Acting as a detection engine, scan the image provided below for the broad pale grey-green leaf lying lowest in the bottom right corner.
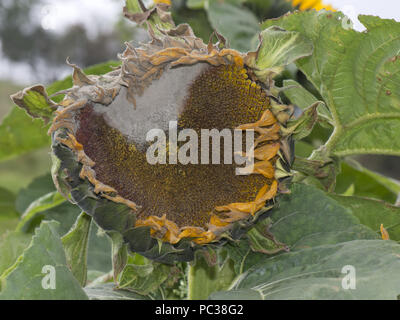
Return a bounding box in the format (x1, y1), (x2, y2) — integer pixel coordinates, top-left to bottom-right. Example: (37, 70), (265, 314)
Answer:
(211, 240), (400, 300)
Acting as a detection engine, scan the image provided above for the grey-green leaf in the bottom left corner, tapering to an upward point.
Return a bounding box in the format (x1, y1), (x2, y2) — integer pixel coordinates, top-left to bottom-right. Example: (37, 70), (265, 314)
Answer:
(0, 222), (87, 300)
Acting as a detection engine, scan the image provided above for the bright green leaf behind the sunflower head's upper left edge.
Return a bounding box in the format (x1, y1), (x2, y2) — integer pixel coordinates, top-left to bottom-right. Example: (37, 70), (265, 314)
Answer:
(0, 61), (119, 161)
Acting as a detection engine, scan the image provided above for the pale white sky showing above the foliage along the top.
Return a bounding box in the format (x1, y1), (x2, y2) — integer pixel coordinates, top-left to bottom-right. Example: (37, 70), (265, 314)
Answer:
(0, 0), (400, 83)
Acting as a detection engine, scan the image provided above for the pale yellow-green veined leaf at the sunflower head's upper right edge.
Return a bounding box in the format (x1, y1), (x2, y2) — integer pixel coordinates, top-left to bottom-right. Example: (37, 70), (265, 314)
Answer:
(249, 27), (313, 81)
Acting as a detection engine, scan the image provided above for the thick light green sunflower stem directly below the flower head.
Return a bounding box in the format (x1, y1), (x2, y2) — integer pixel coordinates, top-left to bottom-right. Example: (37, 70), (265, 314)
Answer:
(188, 252), (236, 300)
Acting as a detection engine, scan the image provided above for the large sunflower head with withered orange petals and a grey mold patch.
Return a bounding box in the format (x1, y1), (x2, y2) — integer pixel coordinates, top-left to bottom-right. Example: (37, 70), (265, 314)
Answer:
(38, 3), (291, 262)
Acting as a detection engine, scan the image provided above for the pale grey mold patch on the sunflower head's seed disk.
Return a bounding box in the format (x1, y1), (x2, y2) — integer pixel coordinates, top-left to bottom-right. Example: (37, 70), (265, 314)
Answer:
(94, 63), (209, 148)
